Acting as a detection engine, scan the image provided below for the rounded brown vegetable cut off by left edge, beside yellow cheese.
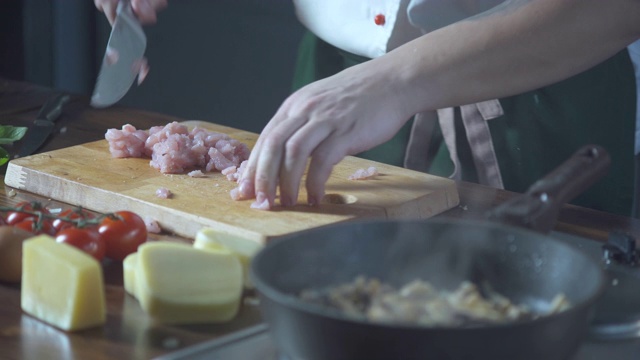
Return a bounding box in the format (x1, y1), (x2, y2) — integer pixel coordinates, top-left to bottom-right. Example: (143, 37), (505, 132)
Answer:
(0, 226), (34, 283)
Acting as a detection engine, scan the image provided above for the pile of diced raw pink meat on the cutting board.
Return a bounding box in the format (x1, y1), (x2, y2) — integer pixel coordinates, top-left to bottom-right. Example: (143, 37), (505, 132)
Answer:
(105, 122), (250, 174)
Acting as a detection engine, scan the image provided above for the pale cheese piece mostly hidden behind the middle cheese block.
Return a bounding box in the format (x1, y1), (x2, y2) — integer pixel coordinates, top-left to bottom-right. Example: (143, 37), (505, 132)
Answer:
(193, 228), (264, 288)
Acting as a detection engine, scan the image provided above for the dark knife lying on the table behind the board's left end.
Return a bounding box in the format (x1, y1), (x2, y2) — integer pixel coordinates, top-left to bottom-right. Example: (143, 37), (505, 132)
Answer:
(18, 94), (70, 157)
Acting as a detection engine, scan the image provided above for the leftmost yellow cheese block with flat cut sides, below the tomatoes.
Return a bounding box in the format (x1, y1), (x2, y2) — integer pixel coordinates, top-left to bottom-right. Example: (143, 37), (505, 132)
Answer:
(20, 235), (106, 331)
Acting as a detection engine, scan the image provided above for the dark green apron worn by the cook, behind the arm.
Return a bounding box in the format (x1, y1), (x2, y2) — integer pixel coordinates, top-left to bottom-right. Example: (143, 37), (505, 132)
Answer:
(293, 33), (636, 216)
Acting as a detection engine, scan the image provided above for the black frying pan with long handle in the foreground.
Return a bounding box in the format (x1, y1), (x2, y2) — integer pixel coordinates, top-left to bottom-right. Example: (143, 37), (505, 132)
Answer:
(251, 146), (609, 360)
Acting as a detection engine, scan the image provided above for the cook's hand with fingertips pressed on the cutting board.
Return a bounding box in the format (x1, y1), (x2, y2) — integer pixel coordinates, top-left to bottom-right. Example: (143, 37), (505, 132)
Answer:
(238, 59), (413, 207)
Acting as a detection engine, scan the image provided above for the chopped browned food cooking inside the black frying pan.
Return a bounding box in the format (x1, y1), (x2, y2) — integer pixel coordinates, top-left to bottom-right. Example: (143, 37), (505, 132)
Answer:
(300, 276), (570, 327)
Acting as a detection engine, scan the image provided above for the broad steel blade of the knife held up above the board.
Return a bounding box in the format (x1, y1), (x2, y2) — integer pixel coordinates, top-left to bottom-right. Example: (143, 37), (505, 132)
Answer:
(91, 0), (147, 108)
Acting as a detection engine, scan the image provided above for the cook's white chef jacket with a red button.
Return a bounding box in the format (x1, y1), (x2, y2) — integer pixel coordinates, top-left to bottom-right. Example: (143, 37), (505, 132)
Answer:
(293, 0), (640, 154)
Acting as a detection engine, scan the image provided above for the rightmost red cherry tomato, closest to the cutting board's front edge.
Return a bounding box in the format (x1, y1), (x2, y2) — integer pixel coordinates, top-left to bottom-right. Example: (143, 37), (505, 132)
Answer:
(98, 211), (147, 261)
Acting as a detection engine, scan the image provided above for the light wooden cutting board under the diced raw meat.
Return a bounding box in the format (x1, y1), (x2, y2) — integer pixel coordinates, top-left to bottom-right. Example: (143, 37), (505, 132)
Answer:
(5, 121), (459, 242)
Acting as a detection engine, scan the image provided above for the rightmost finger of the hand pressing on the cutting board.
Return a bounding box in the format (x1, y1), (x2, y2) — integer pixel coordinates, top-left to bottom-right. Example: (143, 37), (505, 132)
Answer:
(306, 137), (347, 206)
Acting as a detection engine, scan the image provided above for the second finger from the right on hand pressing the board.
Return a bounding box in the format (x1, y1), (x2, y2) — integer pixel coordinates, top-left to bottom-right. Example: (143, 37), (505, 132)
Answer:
(279, 122), (331, 206)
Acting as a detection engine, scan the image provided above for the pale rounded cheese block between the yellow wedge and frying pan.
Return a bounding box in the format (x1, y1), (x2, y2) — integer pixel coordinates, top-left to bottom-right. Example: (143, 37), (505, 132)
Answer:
(134, 241), (242, 324)
